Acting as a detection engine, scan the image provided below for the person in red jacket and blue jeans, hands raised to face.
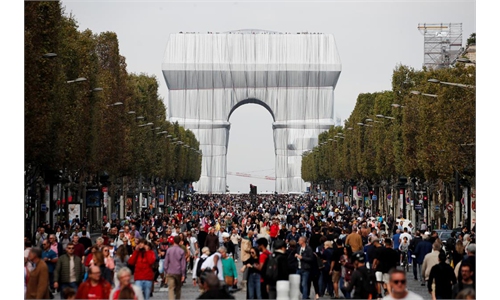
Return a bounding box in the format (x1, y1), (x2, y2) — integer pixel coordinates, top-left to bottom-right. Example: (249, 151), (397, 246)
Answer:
(128, 239), (156, 300)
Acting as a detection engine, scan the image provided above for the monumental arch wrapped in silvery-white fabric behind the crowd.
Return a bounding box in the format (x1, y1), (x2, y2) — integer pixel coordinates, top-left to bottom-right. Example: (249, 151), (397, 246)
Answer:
(162, 30), (342, 193)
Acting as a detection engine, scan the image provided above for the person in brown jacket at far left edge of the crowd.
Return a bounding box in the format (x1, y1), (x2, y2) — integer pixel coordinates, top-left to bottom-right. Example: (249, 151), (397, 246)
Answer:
(26, 247), (50, 299)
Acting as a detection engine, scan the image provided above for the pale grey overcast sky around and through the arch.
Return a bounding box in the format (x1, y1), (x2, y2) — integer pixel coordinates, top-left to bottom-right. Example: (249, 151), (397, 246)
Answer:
(56, 0), (476, 192)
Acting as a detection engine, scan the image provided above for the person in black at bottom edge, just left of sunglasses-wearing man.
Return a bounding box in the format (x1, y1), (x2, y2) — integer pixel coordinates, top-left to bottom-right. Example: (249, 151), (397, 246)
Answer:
(341, 251), (377, 299)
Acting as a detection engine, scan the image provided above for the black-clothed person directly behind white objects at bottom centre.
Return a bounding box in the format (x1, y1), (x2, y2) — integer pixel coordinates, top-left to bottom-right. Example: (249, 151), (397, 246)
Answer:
(266, 240), (288, 299)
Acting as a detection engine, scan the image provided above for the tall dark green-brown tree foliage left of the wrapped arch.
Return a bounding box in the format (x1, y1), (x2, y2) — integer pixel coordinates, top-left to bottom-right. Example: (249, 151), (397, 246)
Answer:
(25, 1), (201, 190)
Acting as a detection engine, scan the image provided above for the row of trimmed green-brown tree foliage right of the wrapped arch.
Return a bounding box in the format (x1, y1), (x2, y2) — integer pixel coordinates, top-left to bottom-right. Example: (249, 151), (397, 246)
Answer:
(302, 64), (476, 192)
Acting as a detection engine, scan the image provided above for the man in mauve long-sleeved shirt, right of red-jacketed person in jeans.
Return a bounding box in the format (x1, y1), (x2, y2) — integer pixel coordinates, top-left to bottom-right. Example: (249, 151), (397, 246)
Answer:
(163, 235), (186, 300)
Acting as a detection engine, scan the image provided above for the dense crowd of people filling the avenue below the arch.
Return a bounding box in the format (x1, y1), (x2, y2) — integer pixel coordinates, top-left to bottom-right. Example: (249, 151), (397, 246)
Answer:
(25, 195), (476, 299)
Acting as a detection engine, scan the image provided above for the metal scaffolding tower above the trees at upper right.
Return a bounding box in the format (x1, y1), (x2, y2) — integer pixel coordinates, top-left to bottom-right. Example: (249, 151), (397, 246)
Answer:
(418, 23), (464, 69)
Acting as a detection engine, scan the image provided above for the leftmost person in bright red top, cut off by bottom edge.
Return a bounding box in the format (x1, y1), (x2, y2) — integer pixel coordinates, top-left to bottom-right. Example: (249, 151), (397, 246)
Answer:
(75, 266), (111, 299)
